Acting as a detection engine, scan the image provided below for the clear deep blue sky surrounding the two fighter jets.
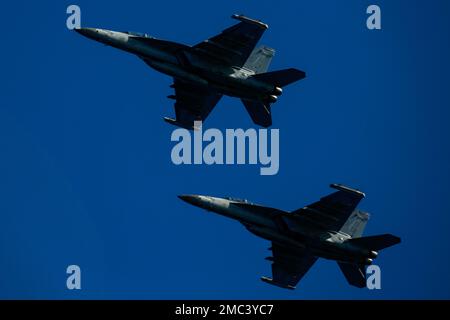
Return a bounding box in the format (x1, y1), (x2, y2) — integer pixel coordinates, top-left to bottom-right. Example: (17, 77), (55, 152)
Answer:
(0, 0), (450, 299)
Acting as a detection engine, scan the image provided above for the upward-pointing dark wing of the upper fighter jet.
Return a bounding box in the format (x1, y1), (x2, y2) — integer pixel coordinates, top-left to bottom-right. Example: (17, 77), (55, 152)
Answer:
(193, 15), (268, 67)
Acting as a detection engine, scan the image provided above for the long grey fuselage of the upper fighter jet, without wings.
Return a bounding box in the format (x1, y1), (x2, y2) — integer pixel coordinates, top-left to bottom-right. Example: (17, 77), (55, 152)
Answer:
(77, 28), (282, 103)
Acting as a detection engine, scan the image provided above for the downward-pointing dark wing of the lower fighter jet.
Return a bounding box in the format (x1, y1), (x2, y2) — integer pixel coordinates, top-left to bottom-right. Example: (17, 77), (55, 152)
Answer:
(261, 242), (317, 289)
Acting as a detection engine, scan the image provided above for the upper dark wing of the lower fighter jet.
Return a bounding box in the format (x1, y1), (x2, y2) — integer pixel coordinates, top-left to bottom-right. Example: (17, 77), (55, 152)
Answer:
(292, 184), (365, 231)
